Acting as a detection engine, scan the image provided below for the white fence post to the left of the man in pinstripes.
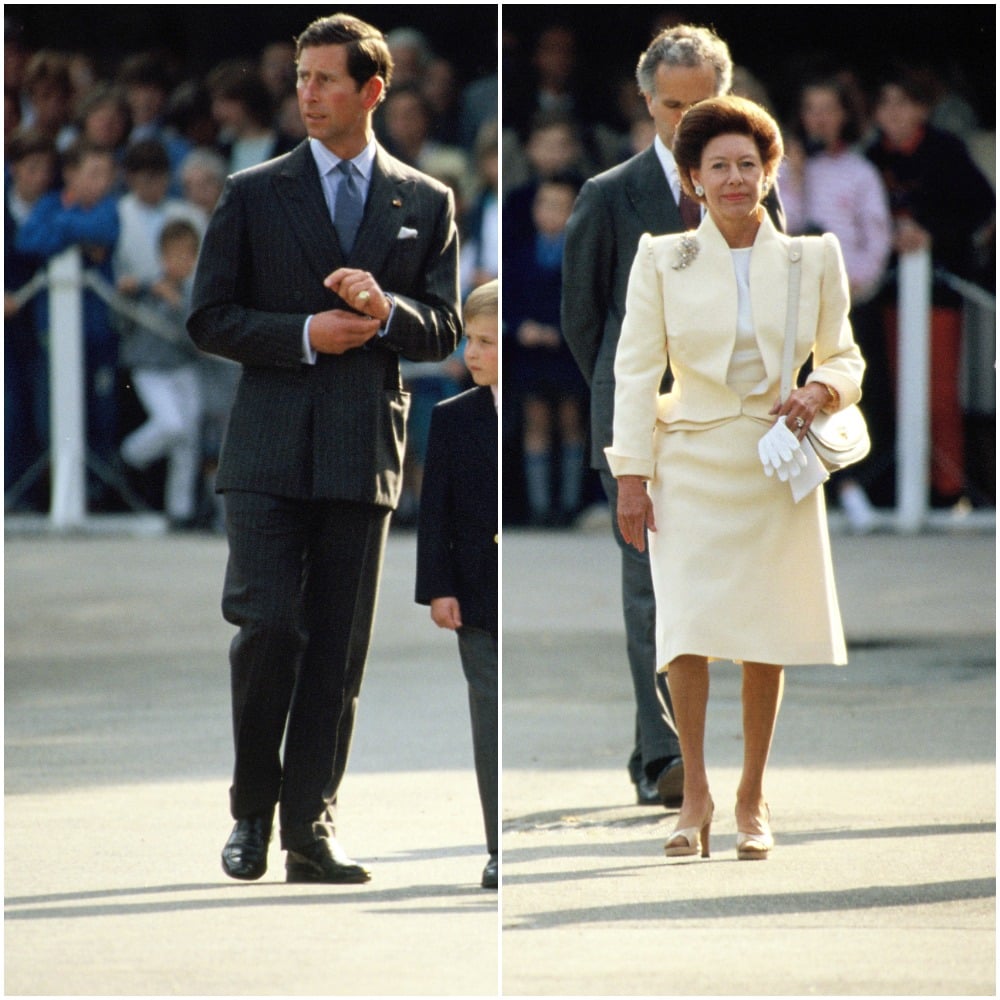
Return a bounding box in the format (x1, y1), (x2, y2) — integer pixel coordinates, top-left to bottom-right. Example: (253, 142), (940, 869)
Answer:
(48, 247), (87, 529)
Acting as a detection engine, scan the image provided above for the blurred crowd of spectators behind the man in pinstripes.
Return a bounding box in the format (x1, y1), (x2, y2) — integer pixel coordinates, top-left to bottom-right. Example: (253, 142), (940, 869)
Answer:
(4, 19), (499, 529)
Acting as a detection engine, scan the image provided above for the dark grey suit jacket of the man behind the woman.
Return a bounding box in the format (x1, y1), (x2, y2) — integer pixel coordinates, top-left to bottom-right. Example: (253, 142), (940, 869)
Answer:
(561, 146), (784, 471)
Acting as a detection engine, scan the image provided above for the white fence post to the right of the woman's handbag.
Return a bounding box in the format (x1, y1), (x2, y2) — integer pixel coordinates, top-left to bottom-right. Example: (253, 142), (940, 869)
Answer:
(896, 250), (931, 532)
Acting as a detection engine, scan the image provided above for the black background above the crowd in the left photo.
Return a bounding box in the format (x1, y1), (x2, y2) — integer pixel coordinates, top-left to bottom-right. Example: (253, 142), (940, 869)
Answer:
(4, 4), (497, 82)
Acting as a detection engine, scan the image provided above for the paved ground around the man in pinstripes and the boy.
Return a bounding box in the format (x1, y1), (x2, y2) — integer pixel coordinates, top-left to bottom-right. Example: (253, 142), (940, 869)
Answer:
(4, 536), (499, 995)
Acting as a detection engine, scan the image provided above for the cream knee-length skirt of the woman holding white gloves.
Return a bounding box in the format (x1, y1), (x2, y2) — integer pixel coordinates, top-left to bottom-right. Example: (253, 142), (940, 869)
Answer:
(649, 417), (847, 672)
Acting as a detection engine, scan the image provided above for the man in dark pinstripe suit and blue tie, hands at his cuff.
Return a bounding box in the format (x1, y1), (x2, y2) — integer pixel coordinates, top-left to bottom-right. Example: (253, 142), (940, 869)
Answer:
(188, 14), (461, 882)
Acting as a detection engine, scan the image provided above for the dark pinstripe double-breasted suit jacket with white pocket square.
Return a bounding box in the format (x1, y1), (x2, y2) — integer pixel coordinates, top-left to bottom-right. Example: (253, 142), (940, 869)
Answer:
(188, 142), (461, 507)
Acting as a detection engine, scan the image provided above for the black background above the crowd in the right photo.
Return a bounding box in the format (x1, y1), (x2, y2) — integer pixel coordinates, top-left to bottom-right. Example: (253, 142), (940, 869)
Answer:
(503, 4), (996, 129)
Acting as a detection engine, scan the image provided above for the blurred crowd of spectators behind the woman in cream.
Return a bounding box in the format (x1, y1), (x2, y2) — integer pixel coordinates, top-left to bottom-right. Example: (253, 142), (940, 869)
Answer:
(501, 17), (995, 530)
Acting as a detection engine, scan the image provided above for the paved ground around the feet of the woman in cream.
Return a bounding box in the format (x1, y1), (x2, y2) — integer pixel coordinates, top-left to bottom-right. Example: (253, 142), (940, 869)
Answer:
(503, 531), (996, 996)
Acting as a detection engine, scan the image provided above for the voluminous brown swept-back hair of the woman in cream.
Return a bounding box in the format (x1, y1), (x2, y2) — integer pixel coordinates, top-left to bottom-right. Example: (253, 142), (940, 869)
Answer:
(674, 95), (785, 197)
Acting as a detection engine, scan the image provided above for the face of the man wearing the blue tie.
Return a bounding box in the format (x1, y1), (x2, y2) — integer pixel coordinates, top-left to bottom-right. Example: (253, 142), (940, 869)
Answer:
(297, 45), (383, 156)
